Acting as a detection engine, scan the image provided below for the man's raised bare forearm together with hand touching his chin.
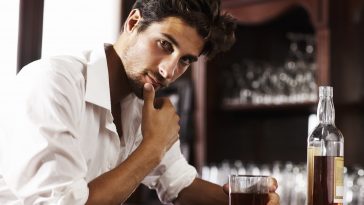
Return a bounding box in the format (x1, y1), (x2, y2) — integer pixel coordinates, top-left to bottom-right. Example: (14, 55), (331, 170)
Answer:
(86, 84), (179, 205)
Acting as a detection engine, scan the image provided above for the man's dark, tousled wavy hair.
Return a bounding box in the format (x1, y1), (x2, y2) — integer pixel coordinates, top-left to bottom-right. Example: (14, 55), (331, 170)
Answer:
(133, 0), (236, 58)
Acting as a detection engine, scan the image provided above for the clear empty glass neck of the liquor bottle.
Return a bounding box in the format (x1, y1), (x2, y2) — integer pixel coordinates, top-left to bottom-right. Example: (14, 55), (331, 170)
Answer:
(317, 97), (335, 125)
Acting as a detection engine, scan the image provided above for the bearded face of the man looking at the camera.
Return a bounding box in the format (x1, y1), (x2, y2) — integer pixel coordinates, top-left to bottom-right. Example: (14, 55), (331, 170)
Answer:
(122, 17), (204, 98)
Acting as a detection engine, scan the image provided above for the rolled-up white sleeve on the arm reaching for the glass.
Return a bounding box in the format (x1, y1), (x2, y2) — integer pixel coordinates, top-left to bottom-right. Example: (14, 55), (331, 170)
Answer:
(143, 141), (197, 204)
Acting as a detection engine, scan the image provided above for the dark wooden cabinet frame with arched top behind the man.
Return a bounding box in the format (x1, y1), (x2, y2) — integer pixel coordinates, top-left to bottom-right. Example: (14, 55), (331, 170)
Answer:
(193, 0), (330, 171)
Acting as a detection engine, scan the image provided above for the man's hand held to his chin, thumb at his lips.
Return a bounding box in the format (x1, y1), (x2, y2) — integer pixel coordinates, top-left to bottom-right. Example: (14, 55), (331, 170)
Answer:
(142, 83), (180, 157)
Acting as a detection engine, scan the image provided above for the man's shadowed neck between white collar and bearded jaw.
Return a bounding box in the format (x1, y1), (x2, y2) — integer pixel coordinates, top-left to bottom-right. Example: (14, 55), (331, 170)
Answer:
(105, 45), (131, 105)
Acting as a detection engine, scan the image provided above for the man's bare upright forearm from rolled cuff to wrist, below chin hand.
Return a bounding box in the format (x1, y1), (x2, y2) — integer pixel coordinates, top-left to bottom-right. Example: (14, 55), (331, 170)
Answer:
(86, 143), (161, 205)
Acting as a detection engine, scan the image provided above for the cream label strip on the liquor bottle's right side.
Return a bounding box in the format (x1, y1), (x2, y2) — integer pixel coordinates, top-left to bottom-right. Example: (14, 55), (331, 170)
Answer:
(334, 157), (344, 203)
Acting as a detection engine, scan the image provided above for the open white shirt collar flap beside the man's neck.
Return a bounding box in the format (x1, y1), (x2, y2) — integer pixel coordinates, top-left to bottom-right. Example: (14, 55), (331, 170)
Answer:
(85, 46), (111, 110)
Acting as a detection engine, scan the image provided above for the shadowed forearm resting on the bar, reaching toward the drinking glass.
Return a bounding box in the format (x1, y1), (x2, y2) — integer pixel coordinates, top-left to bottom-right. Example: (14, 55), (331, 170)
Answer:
(176, 178), (229, 205)
